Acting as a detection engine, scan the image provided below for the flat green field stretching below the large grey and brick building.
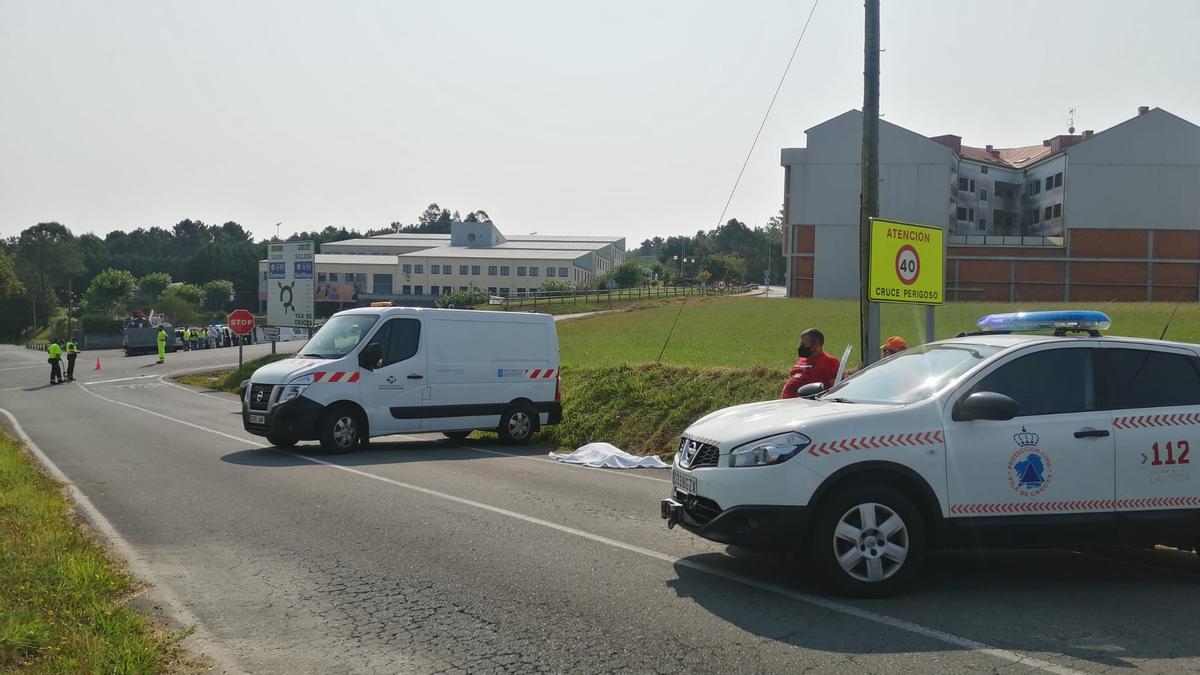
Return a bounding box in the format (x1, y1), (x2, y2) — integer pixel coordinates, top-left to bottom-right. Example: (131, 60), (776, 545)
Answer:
(558, 298), (1200, 368)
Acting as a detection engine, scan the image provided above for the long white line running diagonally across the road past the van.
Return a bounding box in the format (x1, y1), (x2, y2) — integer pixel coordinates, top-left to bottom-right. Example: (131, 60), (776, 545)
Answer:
(72, 389), (1084, 675)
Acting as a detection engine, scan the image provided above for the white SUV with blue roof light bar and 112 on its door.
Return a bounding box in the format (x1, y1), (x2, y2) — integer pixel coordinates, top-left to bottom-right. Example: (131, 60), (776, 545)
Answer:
(661, 311), (1200, 596)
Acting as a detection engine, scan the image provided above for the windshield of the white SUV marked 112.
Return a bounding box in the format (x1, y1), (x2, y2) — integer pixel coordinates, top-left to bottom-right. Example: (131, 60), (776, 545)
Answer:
(821, 345), (1000, 404)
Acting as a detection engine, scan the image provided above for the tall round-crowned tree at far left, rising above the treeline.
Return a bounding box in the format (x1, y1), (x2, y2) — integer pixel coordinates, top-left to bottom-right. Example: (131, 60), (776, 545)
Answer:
(17, 222), (84, 321)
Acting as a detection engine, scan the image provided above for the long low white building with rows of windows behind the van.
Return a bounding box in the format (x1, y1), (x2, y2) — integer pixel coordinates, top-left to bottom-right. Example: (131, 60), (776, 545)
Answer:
(258, 222), (625, 306)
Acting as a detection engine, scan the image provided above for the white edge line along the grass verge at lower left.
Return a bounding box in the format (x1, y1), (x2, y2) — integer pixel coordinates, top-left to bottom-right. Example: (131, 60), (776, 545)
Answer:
(0, 408), (245, 673)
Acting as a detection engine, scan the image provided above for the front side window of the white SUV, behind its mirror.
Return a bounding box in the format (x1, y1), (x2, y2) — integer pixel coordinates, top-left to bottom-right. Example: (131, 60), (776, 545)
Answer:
(972, 347), (1096, 417)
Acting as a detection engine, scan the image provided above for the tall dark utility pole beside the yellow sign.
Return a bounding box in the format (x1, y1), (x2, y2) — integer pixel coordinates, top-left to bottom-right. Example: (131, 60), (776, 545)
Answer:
(858, 0), (880, 364)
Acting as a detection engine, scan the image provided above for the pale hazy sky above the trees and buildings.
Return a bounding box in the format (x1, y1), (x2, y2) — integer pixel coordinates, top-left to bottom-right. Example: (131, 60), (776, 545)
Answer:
(0, 0), (1200, 247)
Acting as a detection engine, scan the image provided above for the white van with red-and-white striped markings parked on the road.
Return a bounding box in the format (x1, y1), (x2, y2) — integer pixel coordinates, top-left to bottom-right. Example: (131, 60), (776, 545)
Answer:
(241, 307), (563, 453)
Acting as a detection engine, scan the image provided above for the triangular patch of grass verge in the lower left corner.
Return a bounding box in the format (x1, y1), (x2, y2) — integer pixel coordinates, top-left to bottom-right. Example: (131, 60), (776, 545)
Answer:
(0, 432), (181, 673)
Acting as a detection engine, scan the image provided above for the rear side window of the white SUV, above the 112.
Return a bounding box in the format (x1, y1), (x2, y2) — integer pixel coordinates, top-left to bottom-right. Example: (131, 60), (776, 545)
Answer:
(1100, 350), (1200, 410)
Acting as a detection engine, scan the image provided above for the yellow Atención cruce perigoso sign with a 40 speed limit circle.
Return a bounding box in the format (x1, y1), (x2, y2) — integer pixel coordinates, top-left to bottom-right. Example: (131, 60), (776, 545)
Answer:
(868, 219), (946, 305)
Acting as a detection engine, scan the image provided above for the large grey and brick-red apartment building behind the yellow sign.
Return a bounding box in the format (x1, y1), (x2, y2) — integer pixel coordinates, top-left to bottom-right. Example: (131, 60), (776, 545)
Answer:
(782, 108), (1200, 301)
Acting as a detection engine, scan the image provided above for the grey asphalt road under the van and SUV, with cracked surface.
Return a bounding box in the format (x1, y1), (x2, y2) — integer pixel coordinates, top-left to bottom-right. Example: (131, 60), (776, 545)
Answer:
(0, 345), (1200, 673)
